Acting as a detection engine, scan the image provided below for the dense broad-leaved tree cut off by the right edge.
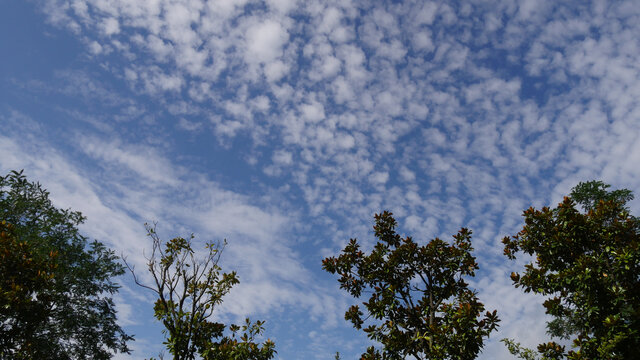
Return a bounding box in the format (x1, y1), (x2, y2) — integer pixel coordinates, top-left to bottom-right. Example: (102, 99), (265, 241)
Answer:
(503, 181), (640, 359)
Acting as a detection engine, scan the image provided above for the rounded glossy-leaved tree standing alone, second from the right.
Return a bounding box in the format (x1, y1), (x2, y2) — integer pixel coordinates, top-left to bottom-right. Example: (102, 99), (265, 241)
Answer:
(322, 211), (499, 359)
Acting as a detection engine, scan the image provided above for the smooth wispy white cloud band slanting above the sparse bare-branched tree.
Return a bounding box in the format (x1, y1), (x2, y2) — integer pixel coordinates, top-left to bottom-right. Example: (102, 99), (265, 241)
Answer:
(0, 108), (350, 356)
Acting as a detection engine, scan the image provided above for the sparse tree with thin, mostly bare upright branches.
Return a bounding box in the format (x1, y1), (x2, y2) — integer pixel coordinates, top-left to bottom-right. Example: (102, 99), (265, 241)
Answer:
(125, 224), (275, 360)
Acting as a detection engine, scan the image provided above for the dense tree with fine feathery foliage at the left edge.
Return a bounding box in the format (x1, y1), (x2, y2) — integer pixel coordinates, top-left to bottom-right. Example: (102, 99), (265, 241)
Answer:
(0, 171), (132, 359)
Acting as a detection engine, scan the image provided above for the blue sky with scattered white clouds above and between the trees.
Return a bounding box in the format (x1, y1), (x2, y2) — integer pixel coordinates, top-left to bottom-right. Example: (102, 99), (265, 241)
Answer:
(0, 0), (640, 359)
